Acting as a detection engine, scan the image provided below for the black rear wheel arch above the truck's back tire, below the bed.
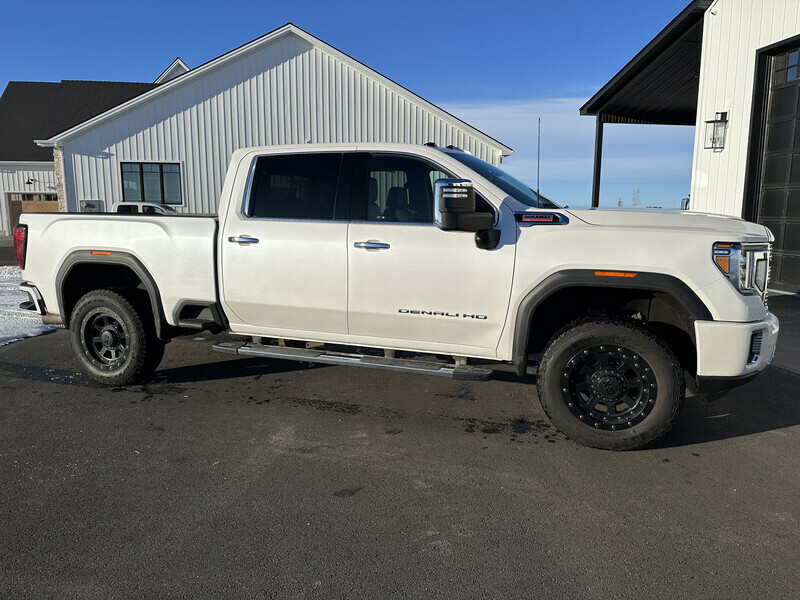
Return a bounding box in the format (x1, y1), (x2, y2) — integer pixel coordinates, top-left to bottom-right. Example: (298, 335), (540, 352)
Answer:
(56, 250), (169, 339)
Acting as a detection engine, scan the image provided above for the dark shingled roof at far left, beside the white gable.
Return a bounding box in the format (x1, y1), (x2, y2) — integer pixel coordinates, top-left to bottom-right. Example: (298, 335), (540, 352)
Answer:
(0, 80), (155, 162)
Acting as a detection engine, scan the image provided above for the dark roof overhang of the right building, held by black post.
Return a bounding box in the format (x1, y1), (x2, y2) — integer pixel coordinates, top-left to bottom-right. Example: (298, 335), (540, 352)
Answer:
(581, 0), (713, 125)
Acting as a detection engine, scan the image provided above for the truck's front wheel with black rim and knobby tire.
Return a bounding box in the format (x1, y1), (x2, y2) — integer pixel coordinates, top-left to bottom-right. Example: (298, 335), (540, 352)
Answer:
(537, 317), (685, 450)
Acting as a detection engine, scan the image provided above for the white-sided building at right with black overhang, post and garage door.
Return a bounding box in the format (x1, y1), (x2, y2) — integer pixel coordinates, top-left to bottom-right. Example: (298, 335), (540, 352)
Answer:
(581, 0), (800, 291)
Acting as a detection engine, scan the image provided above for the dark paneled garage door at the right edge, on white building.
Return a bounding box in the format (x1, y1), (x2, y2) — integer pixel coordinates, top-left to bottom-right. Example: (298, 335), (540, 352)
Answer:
(758, 49), (800, 291)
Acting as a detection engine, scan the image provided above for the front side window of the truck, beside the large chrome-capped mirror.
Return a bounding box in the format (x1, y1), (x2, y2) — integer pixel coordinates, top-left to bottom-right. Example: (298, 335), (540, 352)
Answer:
(367, 154), (452, 223)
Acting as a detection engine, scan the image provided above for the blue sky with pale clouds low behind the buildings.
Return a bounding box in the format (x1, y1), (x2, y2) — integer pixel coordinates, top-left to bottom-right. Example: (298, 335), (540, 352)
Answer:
(0, 0), (694, 207)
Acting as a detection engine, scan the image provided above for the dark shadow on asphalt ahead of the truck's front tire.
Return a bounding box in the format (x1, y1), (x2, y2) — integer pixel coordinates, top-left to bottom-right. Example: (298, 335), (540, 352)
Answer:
(649, 365), (800, 449)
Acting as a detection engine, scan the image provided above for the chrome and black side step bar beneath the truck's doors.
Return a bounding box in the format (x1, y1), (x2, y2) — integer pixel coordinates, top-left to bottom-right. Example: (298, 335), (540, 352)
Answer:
(213, 342), (492, 381)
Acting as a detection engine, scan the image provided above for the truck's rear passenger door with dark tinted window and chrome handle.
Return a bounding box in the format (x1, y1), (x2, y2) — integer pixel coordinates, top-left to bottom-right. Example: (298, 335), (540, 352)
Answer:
(220, 152), (349, 338)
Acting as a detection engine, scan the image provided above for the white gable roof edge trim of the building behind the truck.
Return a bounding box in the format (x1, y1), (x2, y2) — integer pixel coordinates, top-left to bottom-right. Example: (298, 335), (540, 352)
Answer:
(37, 23), (514, 156)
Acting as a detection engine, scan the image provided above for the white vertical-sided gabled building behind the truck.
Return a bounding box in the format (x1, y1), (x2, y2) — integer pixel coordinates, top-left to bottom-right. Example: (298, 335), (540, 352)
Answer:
(39, 24), (513, 212)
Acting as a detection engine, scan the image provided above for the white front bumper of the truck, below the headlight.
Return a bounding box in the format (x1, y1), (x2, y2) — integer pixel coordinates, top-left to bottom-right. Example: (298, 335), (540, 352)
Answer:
(694, 313), (780, 396)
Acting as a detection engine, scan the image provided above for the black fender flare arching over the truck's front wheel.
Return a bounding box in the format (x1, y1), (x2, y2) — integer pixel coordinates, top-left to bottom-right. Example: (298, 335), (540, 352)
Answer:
(512, 269), (713, 377)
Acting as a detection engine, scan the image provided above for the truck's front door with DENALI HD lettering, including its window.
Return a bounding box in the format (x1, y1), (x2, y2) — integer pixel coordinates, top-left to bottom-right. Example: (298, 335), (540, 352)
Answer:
(347, 153), (514, 356)
